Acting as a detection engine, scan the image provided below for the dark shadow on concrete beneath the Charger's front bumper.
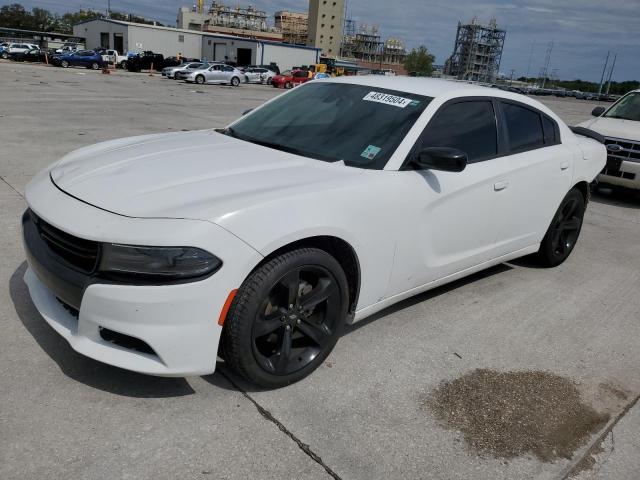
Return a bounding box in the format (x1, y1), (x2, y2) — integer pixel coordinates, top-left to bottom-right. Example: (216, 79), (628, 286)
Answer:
(9, 262), (195, 398)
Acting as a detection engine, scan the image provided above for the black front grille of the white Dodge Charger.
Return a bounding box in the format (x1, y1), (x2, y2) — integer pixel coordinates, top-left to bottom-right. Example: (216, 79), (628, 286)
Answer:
(29, 211), (100, 273)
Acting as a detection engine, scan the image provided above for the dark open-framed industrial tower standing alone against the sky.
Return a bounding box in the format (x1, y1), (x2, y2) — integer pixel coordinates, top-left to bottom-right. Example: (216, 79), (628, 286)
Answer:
(444, 18), (507, 83)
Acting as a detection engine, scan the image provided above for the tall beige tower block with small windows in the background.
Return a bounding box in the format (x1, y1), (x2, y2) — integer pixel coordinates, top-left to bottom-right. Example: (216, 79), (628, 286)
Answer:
(307, 0), (344, 57)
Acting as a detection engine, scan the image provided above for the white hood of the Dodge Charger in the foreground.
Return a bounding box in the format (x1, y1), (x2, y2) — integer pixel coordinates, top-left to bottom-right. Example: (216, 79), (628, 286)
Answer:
(50, 130), (362, 223)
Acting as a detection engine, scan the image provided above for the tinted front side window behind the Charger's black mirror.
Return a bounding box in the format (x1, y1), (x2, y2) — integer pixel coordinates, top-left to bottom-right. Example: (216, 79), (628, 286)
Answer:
(418, 100), (498, 163)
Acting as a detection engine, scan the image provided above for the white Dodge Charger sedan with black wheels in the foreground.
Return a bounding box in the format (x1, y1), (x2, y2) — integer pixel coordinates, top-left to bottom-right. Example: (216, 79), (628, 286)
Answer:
(22, 76), (606, 388)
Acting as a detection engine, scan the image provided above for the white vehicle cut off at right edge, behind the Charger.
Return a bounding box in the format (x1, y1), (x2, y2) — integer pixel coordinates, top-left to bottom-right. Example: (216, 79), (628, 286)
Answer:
(580, 90), (640, 190)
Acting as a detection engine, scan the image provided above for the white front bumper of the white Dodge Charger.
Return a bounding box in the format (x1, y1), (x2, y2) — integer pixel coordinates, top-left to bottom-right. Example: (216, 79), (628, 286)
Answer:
(24, 172), (262, 376)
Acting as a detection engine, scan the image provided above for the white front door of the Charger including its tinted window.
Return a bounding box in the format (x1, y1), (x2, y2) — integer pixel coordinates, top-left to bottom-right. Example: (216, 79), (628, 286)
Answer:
(389, 98), (504, 295)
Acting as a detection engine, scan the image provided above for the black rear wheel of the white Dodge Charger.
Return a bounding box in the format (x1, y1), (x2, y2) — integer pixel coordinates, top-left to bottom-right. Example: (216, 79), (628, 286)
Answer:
(536, 188), (586, 268)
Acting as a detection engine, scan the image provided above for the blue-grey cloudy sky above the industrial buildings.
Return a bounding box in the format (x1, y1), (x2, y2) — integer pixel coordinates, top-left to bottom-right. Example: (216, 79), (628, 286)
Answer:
(10, 0), (640, 82)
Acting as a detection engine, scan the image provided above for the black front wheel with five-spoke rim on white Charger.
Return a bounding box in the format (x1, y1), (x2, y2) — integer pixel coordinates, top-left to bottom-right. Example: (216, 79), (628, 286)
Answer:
(222, 248), (349, 388)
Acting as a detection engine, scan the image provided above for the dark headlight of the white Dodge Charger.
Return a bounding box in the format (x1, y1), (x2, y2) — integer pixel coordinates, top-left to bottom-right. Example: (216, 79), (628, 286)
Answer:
(99, 243), (222, 281)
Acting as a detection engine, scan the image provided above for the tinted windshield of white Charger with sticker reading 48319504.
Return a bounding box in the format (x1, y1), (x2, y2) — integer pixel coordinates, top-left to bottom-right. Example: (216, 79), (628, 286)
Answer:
(224, 82), (432, 170)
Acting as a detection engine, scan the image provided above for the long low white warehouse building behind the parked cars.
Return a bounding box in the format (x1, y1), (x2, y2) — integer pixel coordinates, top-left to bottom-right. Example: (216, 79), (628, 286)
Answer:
(73, 18), (320, 70)
